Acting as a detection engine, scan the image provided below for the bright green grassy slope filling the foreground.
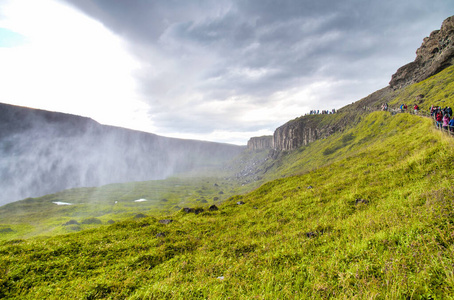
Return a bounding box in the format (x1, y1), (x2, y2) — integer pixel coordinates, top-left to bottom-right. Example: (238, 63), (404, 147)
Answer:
(0, 112), (454, 299)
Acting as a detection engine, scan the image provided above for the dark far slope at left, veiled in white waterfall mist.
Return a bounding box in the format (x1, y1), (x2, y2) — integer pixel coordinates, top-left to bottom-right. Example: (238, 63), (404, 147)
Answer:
(0, 104), (244, 204)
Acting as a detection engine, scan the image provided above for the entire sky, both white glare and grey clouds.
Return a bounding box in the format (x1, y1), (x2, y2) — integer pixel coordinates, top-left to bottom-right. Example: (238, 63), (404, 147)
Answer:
(0, 0), (454, 145)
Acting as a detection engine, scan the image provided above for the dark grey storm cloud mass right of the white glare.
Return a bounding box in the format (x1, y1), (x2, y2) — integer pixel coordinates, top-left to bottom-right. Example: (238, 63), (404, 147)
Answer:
(61, 0), (454, 142)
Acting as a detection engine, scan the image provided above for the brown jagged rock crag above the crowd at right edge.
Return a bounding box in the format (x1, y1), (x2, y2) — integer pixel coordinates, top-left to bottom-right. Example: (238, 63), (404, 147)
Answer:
(389, 16), (454, 89)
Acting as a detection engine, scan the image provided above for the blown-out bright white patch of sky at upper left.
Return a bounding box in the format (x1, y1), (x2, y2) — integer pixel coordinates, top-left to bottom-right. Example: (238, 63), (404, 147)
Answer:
(0, 0), (153, 132)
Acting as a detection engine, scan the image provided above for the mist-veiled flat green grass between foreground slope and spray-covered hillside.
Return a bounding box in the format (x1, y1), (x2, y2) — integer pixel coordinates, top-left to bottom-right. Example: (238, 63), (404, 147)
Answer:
(0, 176), (255, 240)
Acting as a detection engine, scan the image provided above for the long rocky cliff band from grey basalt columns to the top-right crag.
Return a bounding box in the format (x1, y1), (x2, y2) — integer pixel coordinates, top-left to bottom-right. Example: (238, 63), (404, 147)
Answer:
(248, 16), (454, 153)
